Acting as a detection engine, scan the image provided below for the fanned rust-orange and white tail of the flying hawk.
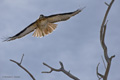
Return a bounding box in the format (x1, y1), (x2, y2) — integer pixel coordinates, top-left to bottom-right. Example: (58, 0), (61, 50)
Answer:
(33, 23), (57, 37)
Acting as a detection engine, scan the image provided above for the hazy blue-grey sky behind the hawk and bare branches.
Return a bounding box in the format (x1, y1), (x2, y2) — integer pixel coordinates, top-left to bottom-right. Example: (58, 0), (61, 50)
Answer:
(0, 0), (120, 80)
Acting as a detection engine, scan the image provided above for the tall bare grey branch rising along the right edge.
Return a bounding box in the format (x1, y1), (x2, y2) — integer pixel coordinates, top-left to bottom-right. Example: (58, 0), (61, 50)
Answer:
(96, 0), (115, 80)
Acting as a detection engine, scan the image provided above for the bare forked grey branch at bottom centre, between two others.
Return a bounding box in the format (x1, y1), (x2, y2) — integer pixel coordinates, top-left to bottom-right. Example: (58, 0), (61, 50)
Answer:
(42, 62), (80, 80)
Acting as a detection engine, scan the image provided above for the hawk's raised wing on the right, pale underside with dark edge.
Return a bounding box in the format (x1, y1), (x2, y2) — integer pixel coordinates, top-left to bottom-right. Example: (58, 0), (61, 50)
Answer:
(46, 9), (83, 23)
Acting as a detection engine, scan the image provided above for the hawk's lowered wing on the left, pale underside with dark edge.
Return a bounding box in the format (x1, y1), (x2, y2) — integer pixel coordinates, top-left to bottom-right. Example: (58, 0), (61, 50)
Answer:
(4, 22), (37, 41)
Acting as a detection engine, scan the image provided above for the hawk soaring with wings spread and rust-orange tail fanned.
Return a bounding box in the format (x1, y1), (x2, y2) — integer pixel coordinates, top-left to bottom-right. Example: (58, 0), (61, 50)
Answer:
(4, 8), (83, 41)
